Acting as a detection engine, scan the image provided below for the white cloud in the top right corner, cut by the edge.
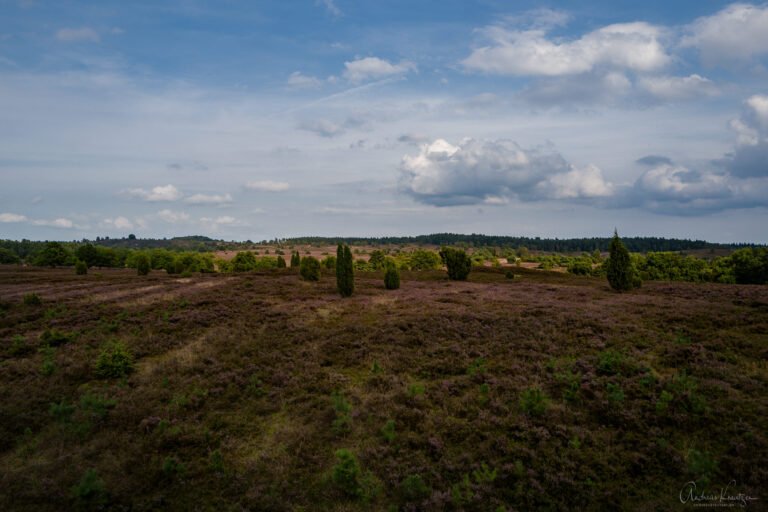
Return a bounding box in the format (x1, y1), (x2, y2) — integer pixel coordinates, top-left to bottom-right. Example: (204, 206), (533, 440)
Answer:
(681, 4), (768, 65)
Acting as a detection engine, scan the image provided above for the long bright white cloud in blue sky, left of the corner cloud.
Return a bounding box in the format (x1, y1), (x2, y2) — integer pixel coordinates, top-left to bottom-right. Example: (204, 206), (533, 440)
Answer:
(462, 22), (671, 76)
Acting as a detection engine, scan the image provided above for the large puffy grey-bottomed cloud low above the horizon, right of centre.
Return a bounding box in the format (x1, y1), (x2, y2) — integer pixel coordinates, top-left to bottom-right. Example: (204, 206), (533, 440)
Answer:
(400, 139), (613, 206)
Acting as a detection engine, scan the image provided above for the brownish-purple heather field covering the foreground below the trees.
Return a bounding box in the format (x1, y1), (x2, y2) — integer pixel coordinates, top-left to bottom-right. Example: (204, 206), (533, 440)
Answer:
(0, 266), (768, 510)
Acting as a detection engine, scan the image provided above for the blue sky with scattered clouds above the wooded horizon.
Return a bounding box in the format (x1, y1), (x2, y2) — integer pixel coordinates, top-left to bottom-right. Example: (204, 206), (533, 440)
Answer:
(0, 0), (768, 243)
